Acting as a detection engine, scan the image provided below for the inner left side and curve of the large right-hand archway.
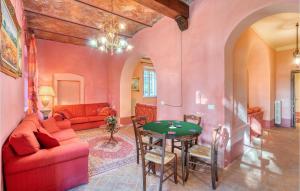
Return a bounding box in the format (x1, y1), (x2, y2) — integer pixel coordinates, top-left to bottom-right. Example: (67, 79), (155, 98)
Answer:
(224, 2), (299, 166)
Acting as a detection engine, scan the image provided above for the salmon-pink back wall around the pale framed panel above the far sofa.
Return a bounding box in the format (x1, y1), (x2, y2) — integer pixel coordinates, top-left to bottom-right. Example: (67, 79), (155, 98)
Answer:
(37, 40), (108, 103)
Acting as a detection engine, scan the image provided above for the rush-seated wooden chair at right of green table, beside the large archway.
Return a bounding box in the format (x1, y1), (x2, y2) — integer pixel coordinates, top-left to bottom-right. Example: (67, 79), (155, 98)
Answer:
(185, 125), (222, 190)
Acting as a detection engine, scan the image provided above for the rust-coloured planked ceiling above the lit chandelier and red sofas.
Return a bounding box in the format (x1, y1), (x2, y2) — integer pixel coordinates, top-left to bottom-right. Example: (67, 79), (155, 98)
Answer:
(24, 0), (162, 45)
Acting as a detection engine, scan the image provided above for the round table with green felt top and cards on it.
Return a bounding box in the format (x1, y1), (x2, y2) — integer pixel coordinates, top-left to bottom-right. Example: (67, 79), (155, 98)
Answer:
(143, 120), (203, 183)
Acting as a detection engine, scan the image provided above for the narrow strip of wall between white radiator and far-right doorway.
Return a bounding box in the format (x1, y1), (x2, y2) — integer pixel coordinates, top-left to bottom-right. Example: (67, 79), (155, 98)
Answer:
(276, 50), (299, 127)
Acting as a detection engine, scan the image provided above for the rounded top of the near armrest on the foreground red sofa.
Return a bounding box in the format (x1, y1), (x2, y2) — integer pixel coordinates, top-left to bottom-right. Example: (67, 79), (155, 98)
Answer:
(4, 140), (89, 175)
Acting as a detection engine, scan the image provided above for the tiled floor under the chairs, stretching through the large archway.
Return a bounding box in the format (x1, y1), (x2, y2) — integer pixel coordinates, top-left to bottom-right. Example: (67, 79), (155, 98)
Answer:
(72, 127), (300, 191)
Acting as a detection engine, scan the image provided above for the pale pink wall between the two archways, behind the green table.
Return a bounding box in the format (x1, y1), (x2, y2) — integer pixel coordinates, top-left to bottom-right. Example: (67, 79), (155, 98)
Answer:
(109, 0), (298, 166)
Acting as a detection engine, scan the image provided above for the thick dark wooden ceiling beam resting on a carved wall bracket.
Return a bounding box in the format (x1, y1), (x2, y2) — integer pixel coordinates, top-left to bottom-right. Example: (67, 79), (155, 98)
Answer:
(134, 0), (189, 31)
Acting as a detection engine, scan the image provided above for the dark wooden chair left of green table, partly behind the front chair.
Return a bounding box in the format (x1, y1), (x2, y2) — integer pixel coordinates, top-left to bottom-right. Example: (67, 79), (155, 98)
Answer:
(131, 116), (147, 164)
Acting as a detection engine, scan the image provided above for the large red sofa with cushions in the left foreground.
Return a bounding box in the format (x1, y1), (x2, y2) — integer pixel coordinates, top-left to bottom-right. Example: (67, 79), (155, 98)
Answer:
(2, 115), (89, 191)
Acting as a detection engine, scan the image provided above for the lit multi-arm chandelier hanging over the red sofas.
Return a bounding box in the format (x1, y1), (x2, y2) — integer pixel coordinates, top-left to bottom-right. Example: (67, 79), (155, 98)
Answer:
(89, 1), (133, 55)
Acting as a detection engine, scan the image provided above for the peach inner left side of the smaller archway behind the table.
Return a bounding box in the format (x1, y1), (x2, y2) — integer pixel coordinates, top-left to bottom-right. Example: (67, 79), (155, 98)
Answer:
(120, 53), (157, 124)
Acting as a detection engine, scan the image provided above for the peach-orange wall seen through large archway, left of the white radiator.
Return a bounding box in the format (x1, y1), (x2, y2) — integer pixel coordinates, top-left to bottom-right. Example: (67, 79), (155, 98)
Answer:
(234, 29), (275, 121)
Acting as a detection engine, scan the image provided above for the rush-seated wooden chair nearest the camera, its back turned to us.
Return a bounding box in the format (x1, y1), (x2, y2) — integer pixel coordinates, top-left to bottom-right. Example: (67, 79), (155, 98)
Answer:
(136, 129), (177, 191)
